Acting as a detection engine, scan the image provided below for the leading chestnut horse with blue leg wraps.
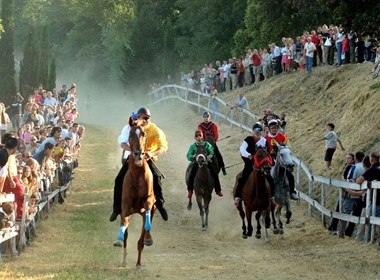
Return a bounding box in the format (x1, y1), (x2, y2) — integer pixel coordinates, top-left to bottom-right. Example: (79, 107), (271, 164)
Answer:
(114, 126), (156, 267)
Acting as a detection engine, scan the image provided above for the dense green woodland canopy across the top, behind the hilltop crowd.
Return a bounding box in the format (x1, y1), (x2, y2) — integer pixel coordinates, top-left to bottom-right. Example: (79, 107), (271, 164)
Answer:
(0, 0), (380, 98)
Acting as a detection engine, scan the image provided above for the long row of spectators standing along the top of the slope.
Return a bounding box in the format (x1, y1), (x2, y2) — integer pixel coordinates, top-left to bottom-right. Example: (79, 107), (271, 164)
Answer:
(176, 25), (380, 94)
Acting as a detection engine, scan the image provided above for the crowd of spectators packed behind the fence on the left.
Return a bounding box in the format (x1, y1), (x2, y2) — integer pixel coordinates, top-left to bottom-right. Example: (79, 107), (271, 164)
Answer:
(0, 83), (85, 249)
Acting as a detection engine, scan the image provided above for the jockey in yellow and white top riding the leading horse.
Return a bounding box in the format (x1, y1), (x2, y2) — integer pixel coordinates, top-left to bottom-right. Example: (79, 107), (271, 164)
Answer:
(110, 108), (168, 222)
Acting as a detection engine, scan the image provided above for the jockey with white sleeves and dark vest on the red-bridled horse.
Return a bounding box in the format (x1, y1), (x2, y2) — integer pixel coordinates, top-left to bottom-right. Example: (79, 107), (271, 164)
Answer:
(234, 123), (277, 207)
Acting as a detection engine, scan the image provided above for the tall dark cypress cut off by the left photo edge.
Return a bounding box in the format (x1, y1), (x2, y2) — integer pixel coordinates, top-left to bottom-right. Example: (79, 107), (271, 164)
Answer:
(0, 0), (17, 104)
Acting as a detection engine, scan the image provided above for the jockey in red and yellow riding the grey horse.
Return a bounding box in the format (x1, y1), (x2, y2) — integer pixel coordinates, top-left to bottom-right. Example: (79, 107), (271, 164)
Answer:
(265, 120), (298, 200)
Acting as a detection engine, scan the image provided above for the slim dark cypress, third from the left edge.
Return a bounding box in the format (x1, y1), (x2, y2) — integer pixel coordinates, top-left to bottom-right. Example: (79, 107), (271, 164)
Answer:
(37, 25), (49, 88)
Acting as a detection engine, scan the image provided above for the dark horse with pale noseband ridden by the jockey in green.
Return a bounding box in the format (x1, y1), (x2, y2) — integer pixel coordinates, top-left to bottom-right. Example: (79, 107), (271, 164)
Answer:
(186, 145), (214, 231)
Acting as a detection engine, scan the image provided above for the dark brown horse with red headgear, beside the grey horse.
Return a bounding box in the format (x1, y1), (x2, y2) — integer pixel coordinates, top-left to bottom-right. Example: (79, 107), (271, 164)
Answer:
(234, 148), (272, 241)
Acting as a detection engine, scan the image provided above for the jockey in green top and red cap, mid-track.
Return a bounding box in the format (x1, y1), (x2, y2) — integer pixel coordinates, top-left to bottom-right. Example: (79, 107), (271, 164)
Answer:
(186, 129), (223, 199)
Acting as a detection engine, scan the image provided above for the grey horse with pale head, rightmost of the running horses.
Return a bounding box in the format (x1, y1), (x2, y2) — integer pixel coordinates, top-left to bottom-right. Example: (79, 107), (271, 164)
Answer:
(271, 143), (294, 234)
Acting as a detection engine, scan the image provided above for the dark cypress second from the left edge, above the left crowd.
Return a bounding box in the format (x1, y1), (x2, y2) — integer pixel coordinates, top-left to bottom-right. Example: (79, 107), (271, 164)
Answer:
(19, 28), (38, 94)
